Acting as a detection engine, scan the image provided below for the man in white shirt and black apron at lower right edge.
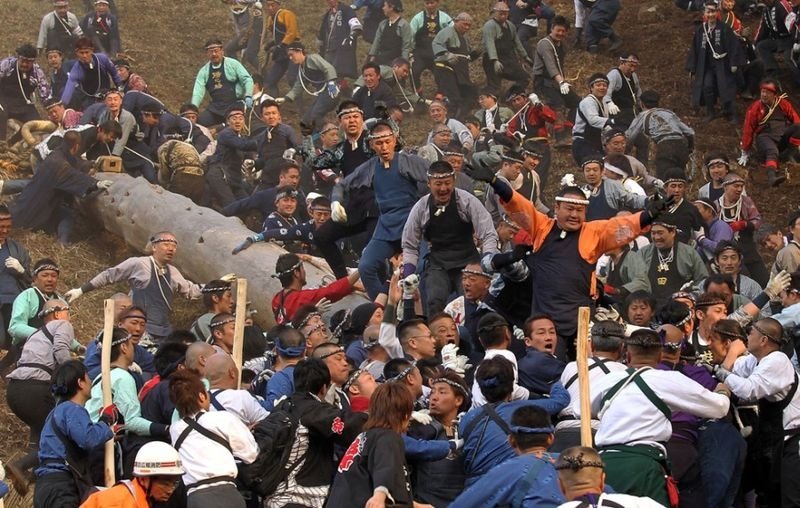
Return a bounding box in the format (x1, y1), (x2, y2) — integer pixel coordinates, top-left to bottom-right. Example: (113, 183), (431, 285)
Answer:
(715, 318), (800, 507)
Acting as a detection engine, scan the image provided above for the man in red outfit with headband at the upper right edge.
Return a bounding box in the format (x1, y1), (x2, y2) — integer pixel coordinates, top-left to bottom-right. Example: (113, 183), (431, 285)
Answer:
(738, 79), (800, 187)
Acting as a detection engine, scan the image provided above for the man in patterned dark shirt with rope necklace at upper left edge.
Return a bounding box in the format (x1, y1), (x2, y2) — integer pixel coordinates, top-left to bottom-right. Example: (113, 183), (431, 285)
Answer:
(0, 44), (51, 151)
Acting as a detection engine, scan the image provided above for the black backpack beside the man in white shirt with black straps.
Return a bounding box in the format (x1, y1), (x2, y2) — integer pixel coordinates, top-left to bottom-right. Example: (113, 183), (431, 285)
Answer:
(238, 400), (303, 497)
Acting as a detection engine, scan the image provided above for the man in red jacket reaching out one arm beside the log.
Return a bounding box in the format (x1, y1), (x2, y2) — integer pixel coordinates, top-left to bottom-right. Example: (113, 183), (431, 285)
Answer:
(272, 254), (359, 324)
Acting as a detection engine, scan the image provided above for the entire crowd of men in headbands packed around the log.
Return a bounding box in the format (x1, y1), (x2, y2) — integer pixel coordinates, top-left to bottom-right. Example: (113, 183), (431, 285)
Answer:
(0, 0), (800, 508)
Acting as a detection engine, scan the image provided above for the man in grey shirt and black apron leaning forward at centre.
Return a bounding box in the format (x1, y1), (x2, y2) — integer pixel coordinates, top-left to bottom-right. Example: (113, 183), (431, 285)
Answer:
(403, 161), (498, 316)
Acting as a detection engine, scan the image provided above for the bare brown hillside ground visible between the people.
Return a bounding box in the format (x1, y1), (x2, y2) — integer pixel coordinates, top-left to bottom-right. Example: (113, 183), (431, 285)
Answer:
(0, 0), (800, 507)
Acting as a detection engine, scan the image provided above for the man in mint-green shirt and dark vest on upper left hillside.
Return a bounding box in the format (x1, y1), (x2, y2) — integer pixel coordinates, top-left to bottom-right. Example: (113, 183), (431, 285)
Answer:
(191, 39), (253, 127)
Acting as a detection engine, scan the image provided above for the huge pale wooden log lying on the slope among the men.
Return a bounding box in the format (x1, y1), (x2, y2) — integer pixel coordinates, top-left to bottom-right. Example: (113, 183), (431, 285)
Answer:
(86, 173), (366, 326)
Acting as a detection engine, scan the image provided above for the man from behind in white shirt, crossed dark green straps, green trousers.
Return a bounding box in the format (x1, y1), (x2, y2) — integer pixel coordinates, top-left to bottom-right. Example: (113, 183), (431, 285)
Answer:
(571, 329), (730, 506)
